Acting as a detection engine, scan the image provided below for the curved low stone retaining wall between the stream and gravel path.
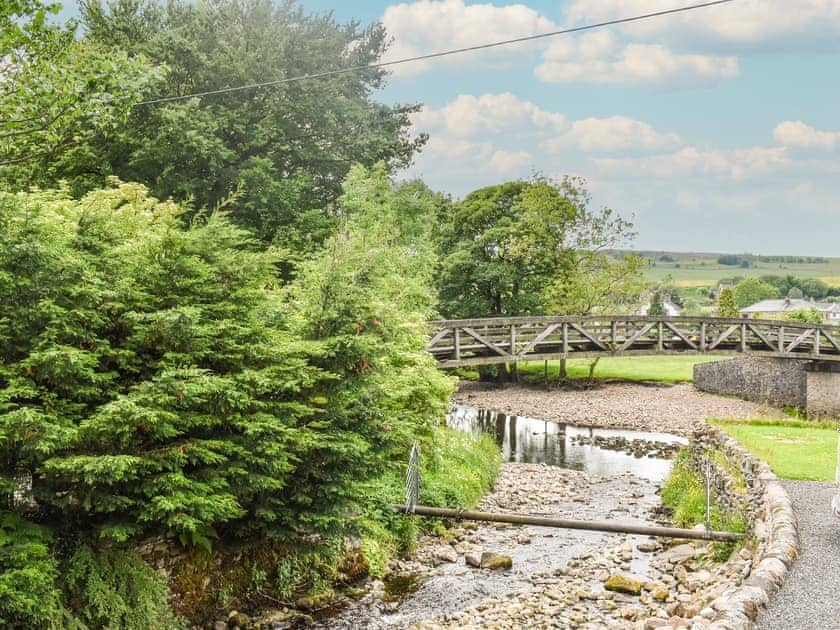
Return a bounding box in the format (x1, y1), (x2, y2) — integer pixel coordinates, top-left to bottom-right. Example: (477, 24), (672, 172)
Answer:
(690, 426), (799, 630)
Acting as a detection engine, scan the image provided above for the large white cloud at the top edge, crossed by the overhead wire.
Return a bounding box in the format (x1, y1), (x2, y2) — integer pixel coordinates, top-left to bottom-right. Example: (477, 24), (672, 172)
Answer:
(381, 0), (556, 76)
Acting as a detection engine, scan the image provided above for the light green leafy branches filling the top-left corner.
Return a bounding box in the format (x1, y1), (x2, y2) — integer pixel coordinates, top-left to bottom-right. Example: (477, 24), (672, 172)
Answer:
(0, 0), (159, 189)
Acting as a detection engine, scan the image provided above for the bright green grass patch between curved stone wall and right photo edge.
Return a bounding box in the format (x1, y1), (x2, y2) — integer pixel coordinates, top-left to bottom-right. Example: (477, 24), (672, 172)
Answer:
(709, 420), (838, 481)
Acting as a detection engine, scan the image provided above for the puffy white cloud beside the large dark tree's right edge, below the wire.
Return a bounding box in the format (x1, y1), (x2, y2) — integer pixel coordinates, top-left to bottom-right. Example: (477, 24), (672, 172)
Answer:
(412, 92), (566, 138)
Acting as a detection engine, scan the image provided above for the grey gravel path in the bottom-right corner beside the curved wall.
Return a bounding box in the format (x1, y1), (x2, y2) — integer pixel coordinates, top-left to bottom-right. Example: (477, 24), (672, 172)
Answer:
(757, 481), (840, 630)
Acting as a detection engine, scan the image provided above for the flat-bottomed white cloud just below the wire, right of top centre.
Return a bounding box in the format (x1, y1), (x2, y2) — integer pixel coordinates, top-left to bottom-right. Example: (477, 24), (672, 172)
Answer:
(534, 31), (738, 86)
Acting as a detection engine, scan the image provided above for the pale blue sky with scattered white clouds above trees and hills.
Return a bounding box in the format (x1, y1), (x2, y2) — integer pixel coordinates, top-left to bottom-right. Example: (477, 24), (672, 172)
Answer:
(59, 0), (840, 256)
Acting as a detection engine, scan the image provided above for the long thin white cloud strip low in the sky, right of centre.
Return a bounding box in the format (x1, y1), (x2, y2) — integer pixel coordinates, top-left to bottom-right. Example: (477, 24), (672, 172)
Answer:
(593, 147), (792, 179)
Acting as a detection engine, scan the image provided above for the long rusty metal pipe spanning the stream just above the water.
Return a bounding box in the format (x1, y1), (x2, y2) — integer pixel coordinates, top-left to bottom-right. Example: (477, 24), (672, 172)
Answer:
(393, 505), (744, 542)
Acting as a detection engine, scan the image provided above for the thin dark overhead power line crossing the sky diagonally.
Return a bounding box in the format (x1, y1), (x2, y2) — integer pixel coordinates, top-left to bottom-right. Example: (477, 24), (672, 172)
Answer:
(137, 0), (735, 106)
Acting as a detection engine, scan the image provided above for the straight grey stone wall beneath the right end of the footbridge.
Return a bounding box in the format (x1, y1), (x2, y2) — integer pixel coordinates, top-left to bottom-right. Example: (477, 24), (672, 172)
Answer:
(694, 357), (808, 410)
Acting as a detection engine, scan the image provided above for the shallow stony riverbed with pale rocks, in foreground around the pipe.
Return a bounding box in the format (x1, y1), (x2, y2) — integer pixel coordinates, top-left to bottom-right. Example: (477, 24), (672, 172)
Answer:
(304, 463), (749, 629)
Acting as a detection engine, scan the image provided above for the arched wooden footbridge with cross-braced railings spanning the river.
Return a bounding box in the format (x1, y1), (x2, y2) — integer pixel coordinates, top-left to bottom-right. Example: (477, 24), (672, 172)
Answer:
(427, 315), (840, 368)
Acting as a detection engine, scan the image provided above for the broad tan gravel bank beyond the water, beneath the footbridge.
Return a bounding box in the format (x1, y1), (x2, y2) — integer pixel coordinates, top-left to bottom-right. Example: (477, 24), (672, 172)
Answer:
(455, 382), (788, 436)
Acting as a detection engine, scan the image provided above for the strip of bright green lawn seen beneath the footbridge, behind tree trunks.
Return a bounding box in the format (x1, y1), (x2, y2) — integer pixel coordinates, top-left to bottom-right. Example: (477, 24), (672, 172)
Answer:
(519, 355), (726, 383)
